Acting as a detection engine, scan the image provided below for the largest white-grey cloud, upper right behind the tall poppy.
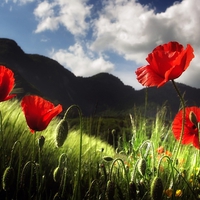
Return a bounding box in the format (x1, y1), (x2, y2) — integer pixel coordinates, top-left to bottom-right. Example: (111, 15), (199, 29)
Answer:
(90, 0), (200, 87)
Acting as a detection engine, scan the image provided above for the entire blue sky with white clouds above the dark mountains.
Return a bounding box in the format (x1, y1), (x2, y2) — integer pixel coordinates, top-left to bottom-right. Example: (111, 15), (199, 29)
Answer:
(0, 0), (200, 89)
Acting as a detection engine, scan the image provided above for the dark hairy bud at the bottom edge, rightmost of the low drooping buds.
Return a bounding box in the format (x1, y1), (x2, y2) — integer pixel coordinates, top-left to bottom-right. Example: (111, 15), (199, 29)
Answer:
(151, 176), (163, 200)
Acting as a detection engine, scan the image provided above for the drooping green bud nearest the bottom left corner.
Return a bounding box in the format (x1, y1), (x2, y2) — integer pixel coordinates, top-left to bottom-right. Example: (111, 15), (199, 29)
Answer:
(2, 166), (15, 191)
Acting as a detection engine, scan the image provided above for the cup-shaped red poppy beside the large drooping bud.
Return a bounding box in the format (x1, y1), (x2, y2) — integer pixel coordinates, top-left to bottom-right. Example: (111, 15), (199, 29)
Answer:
(21, 95), (62, 133)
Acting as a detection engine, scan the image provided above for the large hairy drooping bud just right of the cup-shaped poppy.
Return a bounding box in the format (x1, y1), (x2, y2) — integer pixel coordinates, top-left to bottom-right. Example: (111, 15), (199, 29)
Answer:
(56, 119), (68, 147)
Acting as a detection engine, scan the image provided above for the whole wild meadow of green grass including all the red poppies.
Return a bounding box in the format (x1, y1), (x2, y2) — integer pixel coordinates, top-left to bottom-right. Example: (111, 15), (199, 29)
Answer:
(0, 39), (200, 200)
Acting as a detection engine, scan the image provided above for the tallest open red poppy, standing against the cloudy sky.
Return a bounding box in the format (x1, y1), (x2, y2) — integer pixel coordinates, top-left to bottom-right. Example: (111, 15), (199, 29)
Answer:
(135, 42), (194, 87)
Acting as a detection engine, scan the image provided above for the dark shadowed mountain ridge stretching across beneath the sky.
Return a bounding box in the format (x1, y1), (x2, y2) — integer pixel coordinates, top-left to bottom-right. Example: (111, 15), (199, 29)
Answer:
(0, 38), (200, 115)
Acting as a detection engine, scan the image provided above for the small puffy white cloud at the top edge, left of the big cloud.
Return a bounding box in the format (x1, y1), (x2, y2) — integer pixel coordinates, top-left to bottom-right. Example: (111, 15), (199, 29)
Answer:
(34, 0), (92, 35)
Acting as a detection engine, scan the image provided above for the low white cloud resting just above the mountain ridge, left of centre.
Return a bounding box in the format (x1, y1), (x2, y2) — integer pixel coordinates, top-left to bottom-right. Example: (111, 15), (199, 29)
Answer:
(51, 43), (114, 76)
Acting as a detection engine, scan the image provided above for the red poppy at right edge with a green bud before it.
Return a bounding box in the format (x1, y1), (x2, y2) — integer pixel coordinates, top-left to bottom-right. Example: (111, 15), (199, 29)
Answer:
(172, 106), (200, 149)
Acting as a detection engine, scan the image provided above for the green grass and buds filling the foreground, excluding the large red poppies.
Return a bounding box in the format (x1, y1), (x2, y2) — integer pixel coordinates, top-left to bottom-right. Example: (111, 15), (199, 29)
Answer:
(0, 100), (200, 200)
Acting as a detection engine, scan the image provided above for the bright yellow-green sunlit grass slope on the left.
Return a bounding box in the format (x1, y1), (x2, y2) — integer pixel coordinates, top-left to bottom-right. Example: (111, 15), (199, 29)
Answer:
(0, 101), (114, 199)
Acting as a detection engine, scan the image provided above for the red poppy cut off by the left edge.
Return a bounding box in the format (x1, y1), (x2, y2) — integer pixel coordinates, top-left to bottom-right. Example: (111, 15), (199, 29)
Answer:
(0, 65), (16, 102)
